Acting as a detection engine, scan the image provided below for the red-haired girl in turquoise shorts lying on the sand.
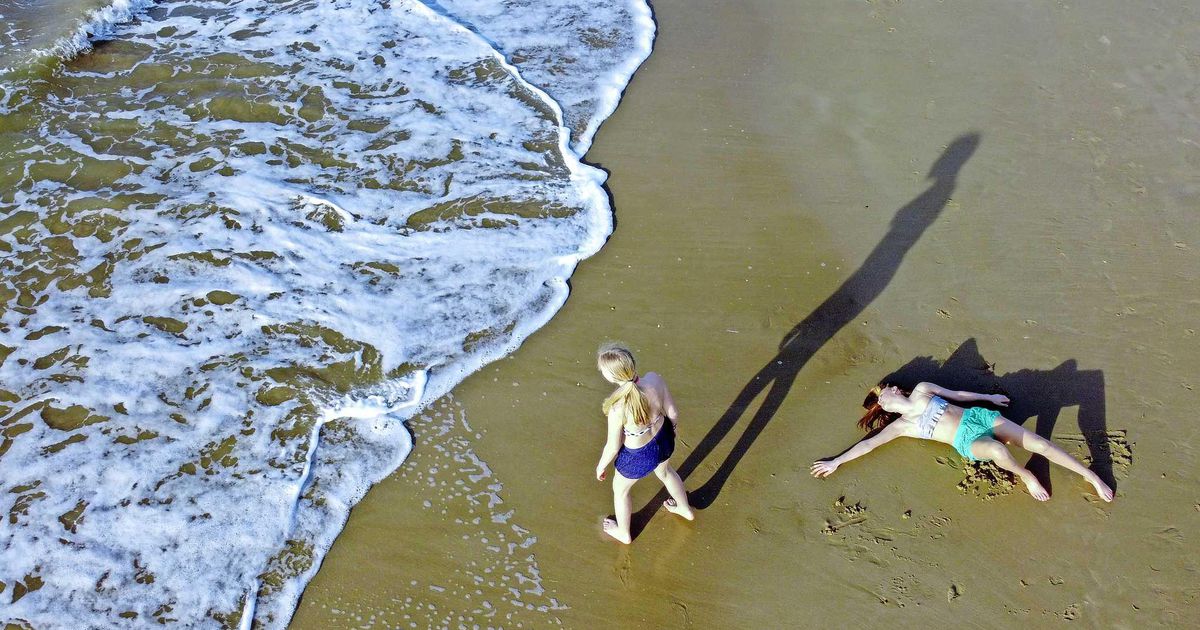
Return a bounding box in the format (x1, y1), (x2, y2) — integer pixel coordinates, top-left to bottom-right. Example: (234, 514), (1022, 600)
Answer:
(811, 383), (1112, 500)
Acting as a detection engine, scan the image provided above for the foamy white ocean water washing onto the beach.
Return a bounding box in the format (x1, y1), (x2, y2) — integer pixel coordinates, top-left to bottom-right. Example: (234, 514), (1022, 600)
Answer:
(0, 0), (654, 628)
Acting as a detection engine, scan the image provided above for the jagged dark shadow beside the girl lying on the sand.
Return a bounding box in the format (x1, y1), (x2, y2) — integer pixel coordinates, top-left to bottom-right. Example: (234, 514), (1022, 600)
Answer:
(881, 338), (1117, 492)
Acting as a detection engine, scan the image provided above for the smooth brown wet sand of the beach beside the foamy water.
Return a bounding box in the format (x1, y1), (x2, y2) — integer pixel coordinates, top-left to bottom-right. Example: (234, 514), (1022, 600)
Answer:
(293, 0), (1200, 628)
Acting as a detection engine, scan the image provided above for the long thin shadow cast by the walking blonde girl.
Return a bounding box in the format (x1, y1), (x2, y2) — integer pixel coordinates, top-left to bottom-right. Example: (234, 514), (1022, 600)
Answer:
(631, 133), (979, 536)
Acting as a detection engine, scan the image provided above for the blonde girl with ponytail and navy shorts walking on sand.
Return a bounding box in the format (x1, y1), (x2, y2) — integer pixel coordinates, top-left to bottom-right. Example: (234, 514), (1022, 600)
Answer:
(596, 343), (695, 545)
